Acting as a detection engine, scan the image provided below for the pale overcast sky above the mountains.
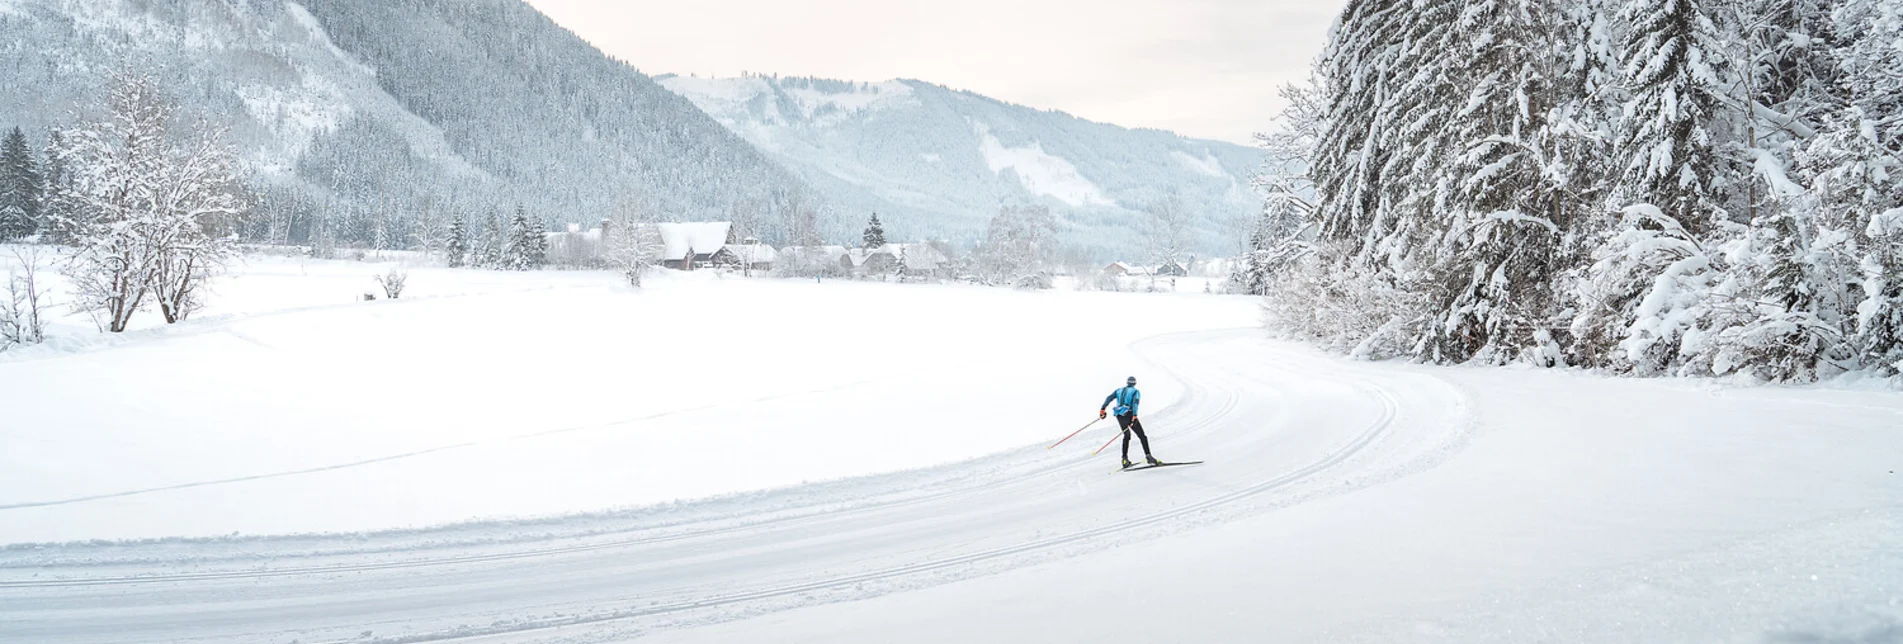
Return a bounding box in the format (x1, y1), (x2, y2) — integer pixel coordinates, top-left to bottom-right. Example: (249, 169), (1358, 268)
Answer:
(529, 0), (1344, 143)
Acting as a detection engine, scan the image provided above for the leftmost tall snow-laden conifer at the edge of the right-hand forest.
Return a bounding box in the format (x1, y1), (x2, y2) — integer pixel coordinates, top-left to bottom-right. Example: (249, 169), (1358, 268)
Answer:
(1290, 0), (1465, 356)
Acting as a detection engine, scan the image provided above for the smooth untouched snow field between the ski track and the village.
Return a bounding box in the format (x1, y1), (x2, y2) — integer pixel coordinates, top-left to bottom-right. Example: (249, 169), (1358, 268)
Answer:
(0, 253), (1254, 543)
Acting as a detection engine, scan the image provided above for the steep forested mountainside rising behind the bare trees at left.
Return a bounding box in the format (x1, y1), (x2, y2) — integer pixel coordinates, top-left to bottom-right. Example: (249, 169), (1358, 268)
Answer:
(0, 0), (807, 248)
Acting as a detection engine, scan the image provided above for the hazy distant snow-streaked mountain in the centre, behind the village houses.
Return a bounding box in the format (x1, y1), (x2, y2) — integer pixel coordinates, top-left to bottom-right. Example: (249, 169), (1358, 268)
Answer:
(657, 74), (1262, 257)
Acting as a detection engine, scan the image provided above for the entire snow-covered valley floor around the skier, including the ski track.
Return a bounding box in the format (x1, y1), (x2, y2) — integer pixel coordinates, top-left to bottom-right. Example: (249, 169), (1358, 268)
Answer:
(0, 253), (1903, 642)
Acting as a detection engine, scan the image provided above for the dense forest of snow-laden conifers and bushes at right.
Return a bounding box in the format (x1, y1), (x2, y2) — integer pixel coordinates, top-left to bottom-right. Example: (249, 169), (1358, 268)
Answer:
(1237, 0), (1903, 381)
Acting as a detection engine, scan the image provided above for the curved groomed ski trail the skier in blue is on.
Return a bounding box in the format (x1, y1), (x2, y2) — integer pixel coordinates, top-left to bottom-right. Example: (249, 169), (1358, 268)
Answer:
(0, 332), (1462, 642)
